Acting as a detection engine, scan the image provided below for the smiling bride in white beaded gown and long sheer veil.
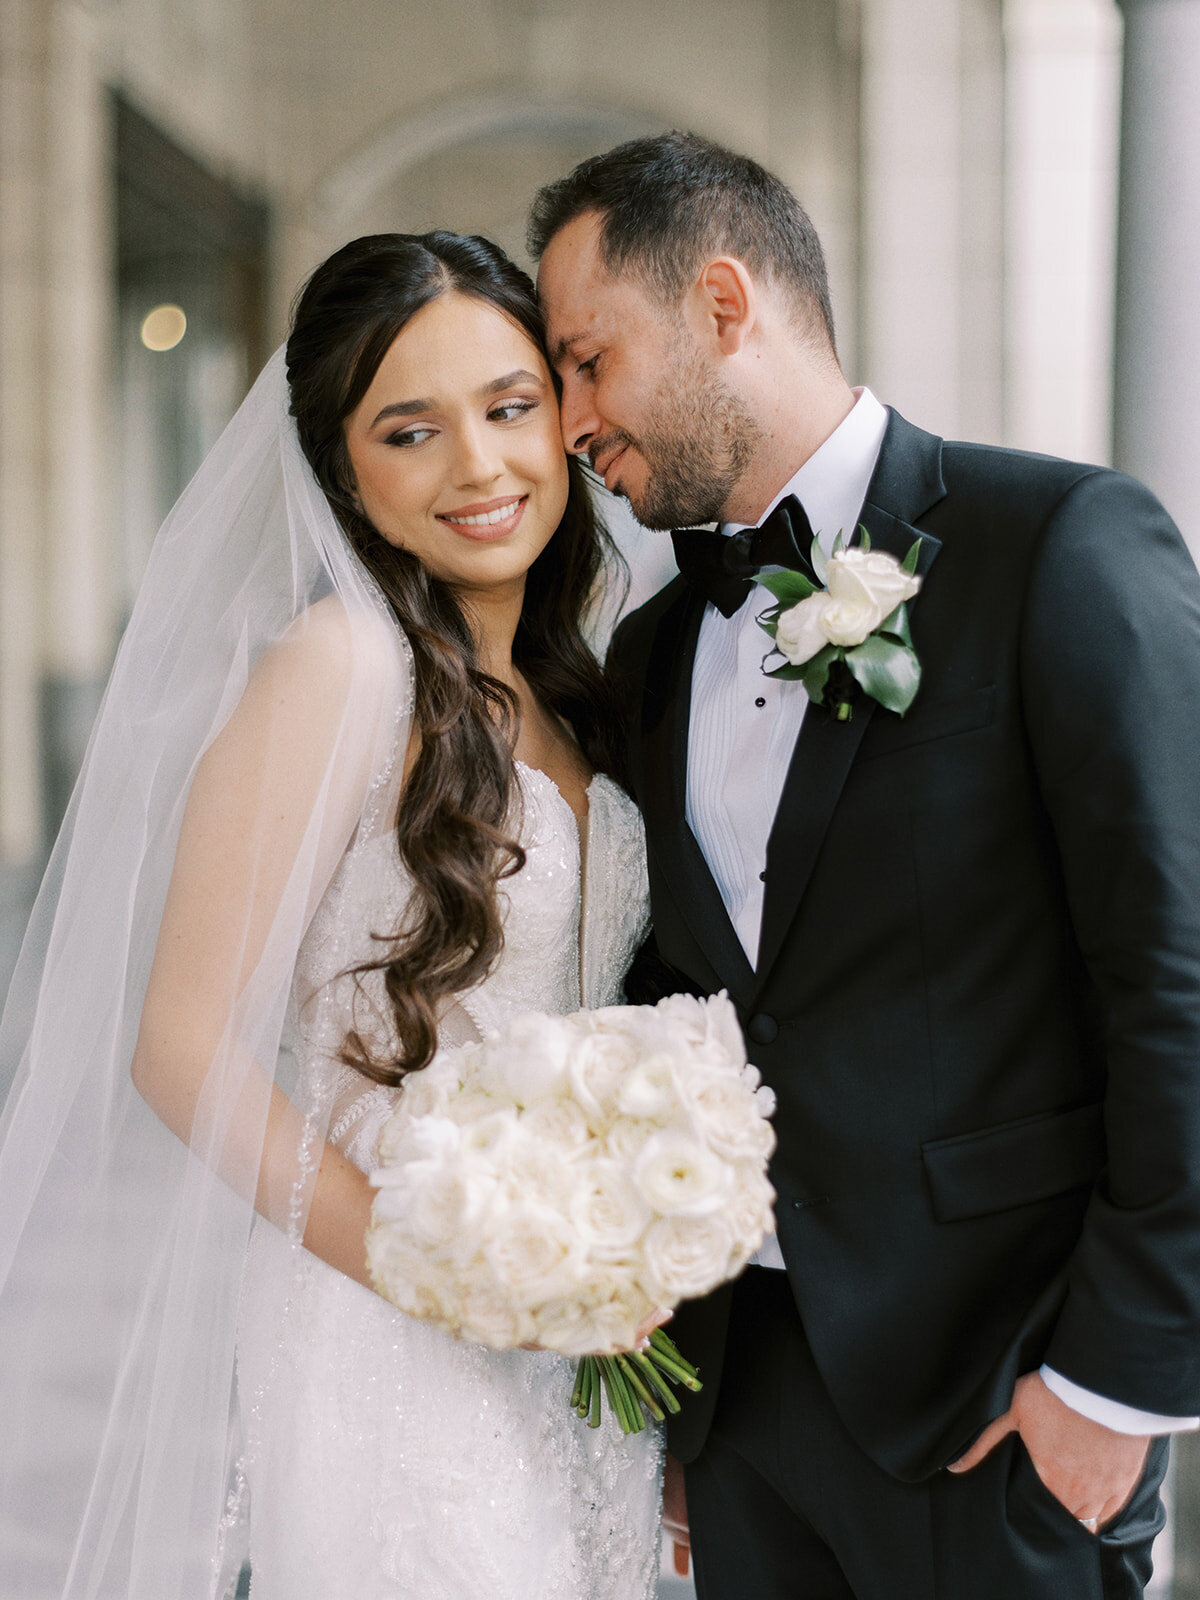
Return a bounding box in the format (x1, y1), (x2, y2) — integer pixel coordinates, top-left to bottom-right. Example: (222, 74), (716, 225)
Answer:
(0, 234), (659, 1600)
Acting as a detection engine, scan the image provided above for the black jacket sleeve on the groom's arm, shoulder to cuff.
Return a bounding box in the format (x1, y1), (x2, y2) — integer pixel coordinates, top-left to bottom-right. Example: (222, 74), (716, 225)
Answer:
(1022, 472), (1200, 1416)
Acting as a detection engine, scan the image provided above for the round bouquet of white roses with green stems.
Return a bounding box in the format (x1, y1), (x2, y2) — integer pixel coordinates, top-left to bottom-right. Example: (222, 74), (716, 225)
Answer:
(366, 994), (774, 1432)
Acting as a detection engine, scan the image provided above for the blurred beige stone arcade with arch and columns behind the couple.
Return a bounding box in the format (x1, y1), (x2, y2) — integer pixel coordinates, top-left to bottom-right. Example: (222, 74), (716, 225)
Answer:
(0, 0), (1200, 1600)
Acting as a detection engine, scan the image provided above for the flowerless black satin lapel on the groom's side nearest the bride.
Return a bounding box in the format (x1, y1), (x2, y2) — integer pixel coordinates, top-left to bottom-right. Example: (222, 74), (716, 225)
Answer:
(640, 589), (754, 1003)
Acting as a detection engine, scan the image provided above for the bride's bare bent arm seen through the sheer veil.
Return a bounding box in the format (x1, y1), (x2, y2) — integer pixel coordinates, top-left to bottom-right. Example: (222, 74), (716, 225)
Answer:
(131, 600), (403, 1283)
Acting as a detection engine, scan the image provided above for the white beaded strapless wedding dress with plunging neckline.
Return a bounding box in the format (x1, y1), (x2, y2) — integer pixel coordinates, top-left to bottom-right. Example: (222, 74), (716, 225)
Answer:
(238, 752), (661, 1600)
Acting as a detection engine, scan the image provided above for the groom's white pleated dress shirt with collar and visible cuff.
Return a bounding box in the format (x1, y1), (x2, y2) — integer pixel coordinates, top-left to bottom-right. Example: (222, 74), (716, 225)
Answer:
(686, 389), (1200, 1434)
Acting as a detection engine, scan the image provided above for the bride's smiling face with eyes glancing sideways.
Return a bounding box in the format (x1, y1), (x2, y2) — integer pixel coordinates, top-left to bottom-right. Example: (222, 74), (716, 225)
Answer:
(346, 291), (566, 590)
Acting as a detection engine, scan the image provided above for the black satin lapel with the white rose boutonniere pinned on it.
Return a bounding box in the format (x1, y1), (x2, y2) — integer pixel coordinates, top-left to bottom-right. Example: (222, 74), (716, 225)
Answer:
(755, 413), (946, 989)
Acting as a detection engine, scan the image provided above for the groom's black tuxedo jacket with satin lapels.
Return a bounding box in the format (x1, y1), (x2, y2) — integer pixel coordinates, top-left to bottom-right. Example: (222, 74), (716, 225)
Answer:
(611, 413), (1200, 1478)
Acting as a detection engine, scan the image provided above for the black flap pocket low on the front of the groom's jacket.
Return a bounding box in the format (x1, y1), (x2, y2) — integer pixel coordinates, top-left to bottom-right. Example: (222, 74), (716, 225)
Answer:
(922, 1104), (1106, 1222)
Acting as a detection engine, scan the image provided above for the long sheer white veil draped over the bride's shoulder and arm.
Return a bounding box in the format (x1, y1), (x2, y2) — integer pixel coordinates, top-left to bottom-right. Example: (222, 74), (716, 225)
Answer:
(0, 352), (410, 1600)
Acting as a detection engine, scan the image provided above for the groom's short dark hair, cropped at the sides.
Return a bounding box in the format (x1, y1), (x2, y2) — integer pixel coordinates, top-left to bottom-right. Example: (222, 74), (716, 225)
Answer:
(528, 133), (834, 347)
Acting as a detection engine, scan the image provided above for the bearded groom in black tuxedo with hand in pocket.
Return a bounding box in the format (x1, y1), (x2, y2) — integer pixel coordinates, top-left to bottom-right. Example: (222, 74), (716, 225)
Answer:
(531, 133), (1200, 1600)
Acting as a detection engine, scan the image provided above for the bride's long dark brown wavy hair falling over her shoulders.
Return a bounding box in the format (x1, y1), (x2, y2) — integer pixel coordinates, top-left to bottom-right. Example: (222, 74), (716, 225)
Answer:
(286, 232), (619, 1085)
